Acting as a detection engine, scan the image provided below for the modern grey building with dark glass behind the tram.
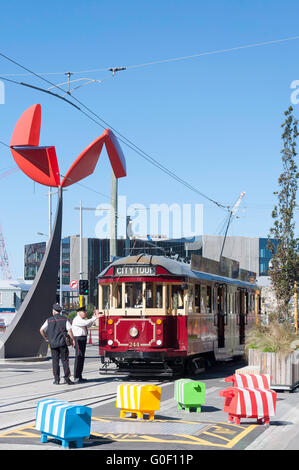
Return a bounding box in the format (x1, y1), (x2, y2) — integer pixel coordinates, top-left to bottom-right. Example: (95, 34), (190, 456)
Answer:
(24, 235), (278, 305)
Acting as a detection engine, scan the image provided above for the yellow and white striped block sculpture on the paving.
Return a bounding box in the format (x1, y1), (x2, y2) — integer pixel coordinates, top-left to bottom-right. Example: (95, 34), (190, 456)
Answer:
(116, 384), (161, 420)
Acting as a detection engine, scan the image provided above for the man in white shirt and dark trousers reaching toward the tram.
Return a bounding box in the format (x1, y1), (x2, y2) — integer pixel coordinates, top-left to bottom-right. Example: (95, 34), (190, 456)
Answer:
(72, 307), (100, 383)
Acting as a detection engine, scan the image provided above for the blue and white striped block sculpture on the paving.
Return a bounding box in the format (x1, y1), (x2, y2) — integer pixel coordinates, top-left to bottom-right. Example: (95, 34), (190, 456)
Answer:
(35, 400), (91, 447)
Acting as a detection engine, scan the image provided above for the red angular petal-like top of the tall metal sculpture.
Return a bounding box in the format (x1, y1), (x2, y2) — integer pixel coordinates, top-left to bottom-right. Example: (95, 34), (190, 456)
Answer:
(10, 104), (126, 188)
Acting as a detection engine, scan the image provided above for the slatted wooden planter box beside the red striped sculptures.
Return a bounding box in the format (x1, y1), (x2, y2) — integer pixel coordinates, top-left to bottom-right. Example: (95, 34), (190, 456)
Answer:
(248, 349), (299, 391)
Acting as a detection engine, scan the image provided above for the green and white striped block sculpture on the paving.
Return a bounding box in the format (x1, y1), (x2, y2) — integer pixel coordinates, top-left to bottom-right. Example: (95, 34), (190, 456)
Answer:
(174, 379), (206, 413)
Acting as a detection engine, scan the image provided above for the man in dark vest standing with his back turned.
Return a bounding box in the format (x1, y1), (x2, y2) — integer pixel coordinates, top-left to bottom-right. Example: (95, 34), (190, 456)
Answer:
(40, 304), (75, 385)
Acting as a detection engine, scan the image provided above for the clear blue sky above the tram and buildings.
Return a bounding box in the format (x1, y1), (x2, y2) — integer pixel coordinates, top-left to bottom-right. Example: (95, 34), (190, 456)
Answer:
(0, 0), (299, 277)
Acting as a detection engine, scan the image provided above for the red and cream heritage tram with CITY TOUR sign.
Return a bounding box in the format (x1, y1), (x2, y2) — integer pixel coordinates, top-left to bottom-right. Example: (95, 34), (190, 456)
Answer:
(98, 254), (258, 376)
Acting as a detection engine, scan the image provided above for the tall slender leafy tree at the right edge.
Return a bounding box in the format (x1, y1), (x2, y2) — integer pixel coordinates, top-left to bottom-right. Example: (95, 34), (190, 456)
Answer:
(267, 106), (299, 319)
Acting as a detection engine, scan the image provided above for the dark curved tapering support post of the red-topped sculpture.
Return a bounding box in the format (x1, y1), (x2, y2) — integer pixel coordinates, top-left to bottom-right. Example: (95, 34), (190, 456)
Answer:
(0, 186), (62, 359)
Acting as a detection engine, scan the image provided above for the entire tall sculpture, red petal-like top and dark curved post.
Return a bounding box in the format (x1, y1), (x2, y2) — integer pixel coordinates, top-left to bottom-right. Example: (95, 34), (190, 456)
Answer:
(0, 104), (126, 358)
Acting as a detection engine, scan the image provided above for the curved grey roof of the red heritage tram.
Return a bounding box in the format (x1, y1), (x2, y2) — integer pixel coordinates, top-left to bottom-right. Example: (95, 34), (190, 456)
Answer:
(98, 254), (257, 289)
